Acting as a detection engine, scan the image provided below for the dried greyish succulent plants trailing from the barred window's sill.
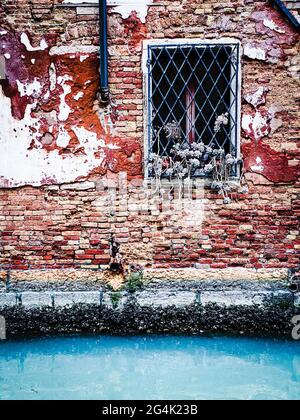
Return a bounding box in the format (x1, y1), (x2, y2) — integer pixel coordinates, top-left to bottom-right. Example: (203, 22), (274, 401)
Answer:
(148, 113), (248, 204)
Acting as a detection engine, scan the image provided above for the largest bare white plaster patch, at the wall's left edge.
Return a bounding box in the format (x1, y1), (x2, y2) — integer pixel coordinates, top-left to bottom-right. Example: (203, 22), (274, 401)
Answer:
(0, 87), (105, 188)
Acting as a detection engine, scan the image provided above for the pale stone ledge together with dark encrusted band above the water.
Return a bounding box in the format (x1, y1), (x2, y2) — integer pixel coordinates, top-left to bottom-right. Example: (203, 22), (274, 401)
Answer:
(0, 283), (300, 336)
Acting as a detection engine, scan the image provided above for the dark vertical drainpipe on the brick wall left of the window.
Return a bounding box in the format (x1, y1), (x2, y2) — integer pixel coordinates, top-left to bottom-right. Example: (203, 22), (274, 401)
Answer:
(99, 0), (109, 104)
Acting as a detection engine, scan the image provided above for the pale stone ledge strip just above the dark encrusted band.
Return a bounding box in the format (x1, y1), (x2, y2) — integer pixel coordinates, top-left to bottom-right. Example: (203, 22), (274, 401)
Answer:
(0, 284), (300, 309)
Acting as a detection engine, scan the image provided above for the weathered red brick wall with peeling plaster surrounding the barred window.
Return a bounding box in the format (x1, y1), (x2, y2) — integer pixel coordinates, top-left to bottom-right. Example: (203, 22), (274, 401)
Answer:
(0, 0), (300, 269)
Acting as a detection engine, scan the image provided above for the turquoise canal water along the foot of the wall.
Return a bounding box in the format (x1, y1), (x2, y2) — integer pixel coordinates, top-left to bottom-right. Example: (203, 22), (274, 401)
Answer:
(0, 336), (300, 400)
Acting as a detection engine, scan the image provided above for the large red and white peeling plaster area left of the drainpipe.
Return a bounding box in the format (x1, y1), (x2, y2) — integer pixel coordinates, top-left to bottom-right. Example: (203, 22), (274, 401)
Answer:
(0, 31), (124, 188)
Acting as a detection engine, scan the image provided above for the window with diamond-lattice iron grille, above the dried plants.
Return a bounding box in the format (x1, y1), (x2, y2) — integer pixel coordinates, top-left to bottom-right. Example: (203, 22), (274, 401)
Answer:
(147, 41), (240, 177)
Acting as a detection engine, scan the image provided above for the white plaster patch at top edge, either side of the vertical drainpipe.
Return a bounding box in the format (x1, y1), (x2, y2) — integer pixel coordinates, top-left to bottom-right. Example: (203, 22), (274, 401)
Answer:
(63, 0), (153, 22)
